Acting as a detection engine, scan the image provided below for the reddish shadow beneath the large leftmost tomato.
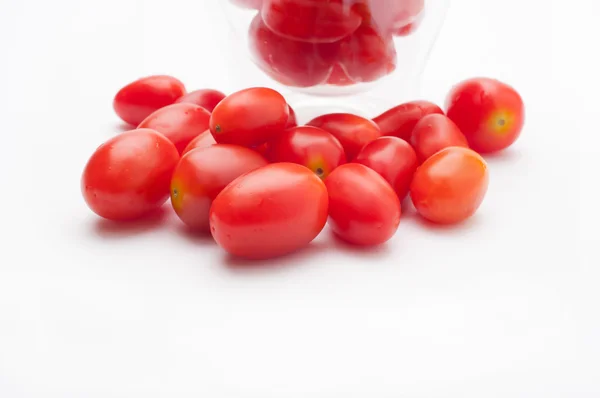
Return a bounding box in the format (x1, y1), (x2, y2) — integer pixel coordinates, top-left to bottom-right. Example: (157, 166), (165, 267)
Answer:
(94, 207), (167, 239)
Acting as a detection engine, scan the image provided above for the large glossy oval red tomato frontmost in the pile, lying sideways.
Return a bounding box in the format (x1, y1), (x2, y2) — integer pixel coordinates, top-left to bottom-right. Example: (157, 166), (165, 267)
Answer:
(210, 163), (328, 260)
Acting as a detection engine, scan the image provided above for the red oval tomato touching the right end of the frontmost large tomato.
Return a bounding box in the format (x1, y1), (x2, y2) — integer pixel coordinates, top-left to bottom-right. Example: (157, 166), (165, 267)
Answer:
(325, 163), (401, 246)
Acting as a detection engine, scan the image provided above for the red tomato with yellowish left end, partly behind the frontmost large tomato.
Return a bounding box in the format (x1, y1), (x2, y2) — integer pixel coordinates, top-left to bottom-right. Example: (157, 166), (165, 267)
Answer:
(171, 144), (268, 232)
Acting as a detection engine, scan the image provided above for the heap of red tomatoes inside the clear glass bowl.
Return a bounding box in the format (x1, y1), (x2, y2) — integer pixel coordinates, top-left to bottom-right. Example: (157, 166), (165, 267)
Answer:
(231, 0), (424, 87)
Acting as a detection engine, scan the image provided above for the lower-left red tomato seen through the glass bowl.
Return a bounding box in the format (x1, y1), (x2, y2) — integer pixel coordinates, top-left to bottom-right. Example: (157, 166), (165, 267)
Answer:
(249, 15), (336, 87)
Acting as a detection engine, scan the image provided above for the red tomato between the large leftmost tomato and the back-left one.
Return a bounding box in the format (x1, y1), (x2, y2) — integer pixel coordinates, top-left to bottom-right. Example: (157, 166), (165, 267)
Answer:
(138, 103), (210, 153)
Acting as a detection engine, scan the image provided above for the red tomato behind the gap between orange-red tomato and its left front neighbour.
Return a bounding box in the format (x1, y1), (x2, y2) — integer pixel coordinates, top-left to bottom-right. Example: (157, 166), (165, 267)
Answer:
(354, 137), (419, 200)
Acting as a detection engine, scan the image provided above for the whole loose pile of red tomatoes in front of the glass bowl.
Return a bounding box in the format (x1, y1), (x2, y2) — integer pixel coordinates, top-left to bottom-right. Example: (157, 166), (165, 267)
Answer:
(82, 76), (524, 259)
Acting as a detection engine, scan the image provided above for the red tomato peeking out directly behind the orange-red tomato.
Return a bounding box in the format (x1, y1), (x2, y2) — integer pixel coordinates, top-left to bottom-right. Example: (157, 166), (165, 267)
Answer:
(410, 113), (469, 163)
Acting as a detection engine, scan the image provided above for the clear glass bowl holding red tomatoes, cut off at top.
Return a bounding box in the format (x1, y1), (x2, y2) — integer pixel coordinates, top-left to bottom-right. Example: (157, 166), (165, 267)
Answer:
(223, 0), (449, 116)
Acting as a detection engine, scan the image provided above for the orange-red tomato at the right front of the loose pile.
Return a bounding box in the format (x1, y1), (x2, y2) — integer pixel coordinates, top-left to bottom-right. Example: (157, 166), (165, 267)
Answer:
(410, 147), (489, 224)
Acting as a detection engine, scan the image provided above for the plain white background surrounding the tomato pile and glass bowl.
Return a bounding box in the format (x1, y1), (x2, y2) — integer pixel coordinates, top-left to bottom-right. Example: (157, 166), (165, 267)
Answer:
(0, 0), (600, 398)
